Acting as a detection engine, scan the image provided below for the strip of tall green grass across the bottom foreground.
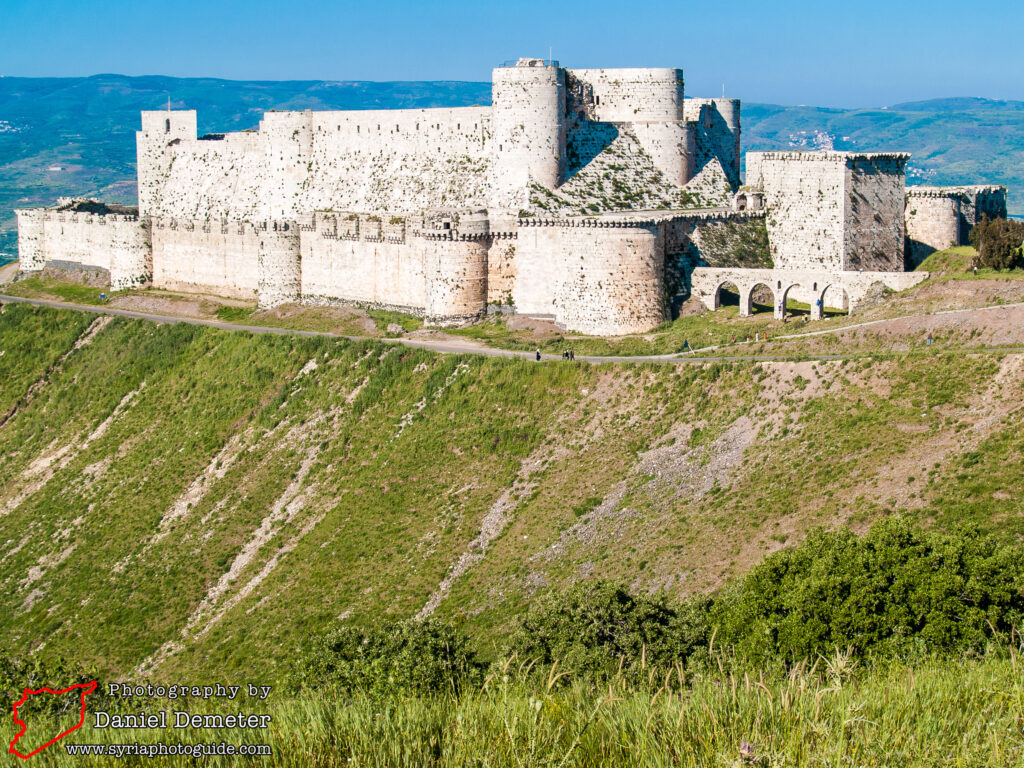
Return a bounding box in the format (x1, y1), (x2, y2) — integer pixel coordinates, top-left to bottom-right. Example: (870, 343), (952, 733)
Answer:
(0, 657), (1024, 768)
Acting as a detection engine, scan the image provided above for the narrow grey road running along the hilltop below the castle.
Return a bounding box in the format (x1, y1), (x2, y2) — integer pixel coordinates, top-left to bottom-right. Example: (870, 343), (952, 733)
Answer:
(0, 294), (1024, 364)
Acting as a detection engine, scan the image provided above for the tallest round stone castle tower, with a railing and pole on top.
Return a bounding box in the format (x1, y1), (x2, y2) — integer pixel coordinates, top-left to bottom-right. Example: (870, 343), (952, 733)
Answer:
(492, 58), (565, 207)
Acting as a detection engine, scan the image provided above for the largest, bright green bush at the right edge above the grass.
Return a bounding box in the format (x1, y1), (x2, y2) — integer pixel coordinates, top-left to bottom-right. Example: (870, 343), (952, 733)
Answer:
(711, 518), (1024, 664)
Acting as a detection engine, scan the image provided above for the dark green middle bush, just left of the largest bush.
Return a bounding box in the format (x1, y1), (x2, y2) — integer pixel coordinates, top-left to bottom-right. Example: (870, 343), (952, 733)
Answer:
(506, 582), (708, 677)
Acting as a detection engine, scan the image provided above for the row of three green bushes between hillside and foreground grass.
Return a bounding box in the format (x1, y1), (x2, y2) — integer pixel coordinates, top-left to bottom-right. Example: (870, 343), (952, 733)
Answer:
(294, 518), (1024, 693)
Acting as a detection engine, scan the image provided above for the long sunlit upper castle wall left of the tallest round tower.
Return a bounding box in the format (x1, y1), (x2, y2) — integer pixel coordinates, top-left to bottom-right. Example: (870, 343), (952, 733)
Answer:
(138, 108), (492, 220)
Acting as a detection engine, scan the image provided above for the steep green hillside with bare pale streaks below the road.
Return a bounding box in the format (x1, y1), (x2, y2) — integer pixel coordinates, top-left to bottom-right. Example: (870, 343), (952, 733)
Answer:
(0, 305), (1024, 681)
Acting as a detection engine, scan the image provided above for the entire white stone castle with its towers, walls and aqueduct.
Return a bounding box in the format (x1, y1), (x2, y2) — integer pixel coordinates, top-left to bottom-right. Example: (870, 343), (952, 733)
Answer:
(17, 58), (1006, 335)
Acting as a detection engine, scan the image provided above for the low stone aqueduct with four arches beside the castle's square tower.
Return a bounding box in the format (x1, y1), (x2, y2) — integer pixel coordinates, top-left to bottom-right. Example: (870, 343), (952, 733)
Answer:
(690, 267), (928, 319)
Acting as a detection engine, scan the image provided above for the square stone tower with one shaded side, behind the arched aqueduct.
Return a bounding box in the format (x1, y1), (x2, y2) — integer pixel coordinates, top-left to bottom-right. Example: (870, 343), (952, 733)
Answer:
(746, 152), (910, 272)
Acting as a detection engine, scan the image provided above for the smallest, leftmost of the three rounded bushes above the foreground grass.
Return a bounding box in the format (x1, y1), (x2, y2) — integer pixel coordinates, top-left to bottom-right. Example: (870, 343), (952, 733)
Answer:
(297, 618), (482, 694)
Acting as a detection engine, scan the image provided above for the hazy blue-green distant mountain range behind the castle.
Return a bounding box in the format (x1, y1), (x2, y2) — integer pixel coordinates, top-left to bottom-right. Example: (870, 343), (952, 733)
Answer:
(0, 75), (1024, 262)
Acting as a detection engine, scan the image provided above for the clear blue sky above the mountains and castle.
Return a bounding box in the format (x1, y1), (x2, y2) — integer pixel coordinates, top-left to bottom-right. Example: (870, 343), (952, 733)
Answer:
(0, 0), (1024, 106)
